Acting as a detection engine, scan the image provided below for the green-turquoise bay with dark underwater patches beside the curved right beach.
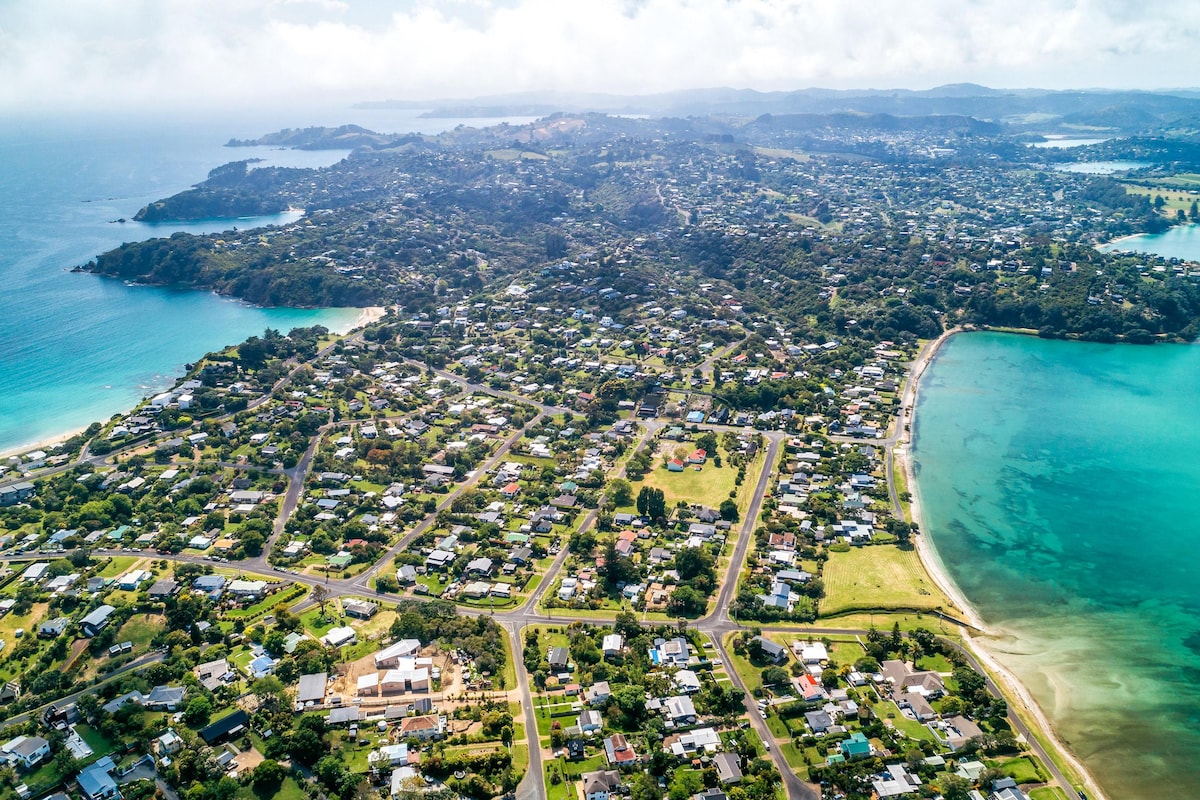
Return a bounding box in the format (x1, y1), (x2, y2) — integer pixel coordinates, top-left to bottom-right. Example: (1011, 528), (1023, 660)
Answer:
(913, 333), (1200, 799)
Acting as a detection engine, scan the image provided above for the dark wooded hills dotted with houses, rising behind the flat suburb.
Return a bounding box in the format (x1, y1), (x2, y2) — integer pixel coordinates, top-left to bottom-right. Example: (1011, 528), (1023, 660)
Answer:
(85, 115), (1200, 342)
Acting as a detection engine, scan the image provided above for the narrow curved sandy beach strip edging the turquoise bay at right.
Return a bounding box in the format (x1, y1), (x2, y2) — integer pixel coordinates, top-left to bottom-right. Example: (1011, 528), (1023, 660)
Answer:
(893, 327), (1108, 800)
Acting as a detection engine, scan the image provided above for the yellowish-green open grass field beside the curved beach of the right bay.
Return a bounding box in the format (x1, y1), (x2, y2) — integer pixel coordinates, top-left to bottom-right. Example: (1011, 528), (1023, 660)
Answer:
(821, 546), (953, 616)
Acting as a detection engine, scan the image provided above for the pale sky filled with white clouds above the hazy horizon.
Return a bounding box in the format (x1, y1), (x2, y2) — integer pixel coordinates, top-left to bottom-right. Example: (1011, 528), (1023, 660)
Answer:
(0, 0), (1200, 113)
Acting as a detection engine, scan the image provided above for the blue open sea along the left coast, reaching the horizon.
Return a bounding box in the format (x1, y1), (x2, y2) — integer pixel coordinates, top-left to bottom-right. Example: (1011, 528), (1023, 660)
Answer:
(0, 108), (540, 452)
